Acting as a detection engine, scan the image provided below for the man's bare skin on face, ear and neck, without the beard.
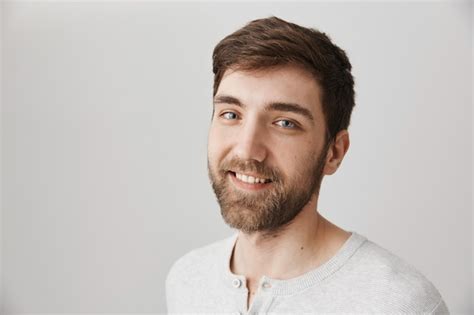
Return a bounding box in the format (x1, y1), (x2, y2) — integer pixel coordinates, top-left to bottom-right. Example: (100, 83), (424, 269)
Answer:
(208, 66), (350, 307)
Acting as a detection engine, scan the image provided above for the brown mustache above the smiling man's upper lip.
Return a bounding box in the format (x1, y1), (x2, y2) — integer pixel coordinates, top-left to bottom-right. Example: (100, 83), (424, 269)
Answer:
(221, 157), (281, 181)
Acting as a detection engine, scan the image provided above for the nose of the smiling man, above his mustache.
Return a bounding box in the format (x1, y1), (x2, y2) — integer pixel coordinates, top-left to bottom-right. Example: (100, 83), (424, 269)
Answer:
(235, 121), (268, 162)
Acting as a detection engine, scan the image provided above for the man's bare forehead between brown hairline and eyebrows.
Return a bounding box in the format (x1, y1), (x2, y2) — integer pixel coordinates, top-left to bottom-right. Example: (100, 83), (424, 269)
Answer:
(216, 66), (321, 116)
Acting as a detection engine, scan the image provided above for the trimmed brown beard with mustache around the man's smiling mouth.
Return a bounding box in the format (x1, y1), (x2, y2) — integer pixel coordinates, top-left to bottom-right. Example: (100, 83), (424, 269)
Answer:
(208, 143), (328, 233)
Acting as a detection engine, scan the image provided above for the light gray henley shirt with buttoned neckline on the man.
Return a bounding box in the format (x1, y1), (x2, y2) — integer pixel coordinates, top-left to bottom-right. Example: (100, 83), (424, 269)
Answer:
(166, 232), (449, 314)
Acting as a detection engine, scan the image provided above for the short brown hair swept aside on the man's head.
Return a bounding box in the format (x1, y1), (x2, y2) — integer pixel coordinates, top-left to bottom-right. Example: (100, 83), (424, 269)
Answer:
(212, 17), (355, 141)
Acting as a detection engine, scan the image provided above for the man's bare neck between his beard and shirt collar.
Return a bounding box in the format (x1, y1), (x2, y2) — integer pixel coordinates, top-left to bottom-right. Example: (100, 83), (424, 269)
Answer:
(230, 196), (349, 283)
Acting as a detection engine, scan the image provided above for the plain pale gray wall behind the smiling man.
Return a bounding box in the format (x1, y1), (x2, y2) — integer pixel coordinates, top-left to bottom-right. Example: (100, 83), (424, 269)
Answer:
(1, 2), (474, 314)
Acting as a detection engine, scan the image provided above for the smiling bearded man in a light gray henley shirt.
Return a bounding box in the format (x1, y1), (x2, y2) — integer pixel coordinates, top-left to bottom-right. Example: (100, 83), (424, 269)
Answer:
(166, 17), (448, 314)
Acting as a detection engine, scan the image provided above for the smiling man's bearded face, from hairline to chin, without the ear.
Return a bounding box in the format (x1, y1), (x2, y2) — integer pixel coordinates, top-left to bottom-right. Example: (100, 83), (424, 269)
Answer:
(208, 66), (327, 233)
